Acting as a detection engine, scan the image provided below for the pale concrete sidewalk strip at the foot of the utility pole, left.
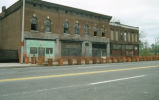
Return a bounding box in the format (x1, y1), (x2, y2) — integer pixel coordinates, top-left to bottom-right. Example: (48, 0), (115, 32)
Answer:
(0, 63), (37, 68)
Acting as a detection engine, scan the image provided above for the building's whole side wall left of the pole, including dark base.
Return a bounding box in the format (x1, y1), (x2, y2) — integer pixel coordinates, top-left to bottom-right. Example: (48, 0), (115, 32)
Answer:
(0, 9), (21, 59)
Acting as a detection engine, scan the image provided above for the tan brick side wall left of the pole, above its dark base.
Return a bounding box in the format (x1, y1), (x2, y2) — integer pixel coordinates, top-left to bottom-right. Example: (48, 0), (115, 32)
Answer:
(0, 9), (21, 50)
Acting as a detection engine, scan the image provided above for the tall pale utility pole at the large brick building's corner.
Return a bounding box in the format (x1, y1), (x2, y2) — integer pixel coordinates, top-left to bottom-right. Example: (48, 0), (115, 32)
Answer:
(20, 0), (25, 64)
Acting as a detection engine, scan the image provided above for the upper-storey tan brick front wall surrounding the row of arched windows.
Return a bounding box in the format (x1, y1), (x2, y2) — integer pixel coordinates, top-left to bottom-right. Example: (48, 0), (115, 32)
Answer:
(25, 4), (110, 37)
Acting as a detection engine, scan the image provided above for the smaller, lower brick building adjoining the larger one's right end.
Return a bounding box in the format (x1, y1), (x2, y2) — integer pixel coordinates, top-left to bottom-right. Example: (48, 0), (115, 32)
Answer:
(109, 22), (139, 56)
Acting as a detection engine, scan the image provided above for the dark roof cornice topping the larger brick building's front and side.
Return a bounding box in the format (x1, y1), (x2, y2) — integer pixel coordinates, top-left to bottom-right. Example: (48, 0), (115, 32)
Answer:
(0, 0), (112, 21)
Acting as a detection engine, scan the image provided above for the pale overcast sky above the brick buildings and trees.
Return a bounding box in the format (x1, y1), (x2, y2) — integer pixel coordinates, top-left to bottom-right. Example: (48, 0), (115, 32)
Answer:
(0, 0), (159, 44)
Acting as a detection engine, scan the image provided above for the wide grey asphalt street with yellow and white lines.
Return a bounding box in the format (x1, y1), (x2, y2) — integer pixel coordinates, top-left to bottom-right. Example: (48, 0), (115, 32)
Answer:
(0, 61), (159, 100)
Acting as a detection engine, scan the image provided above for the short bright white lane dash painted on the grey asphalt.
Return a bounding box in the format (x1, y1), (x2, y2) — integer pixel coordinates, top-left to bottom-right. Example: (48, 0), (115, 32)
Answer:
(89, 75), (145, 85)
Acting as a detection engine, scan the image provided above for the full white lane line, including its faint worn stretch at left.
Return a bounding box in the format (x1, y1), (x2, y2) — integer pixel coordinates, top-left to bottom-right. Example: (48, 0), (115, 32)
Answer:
(0, 75), (146, 96)
